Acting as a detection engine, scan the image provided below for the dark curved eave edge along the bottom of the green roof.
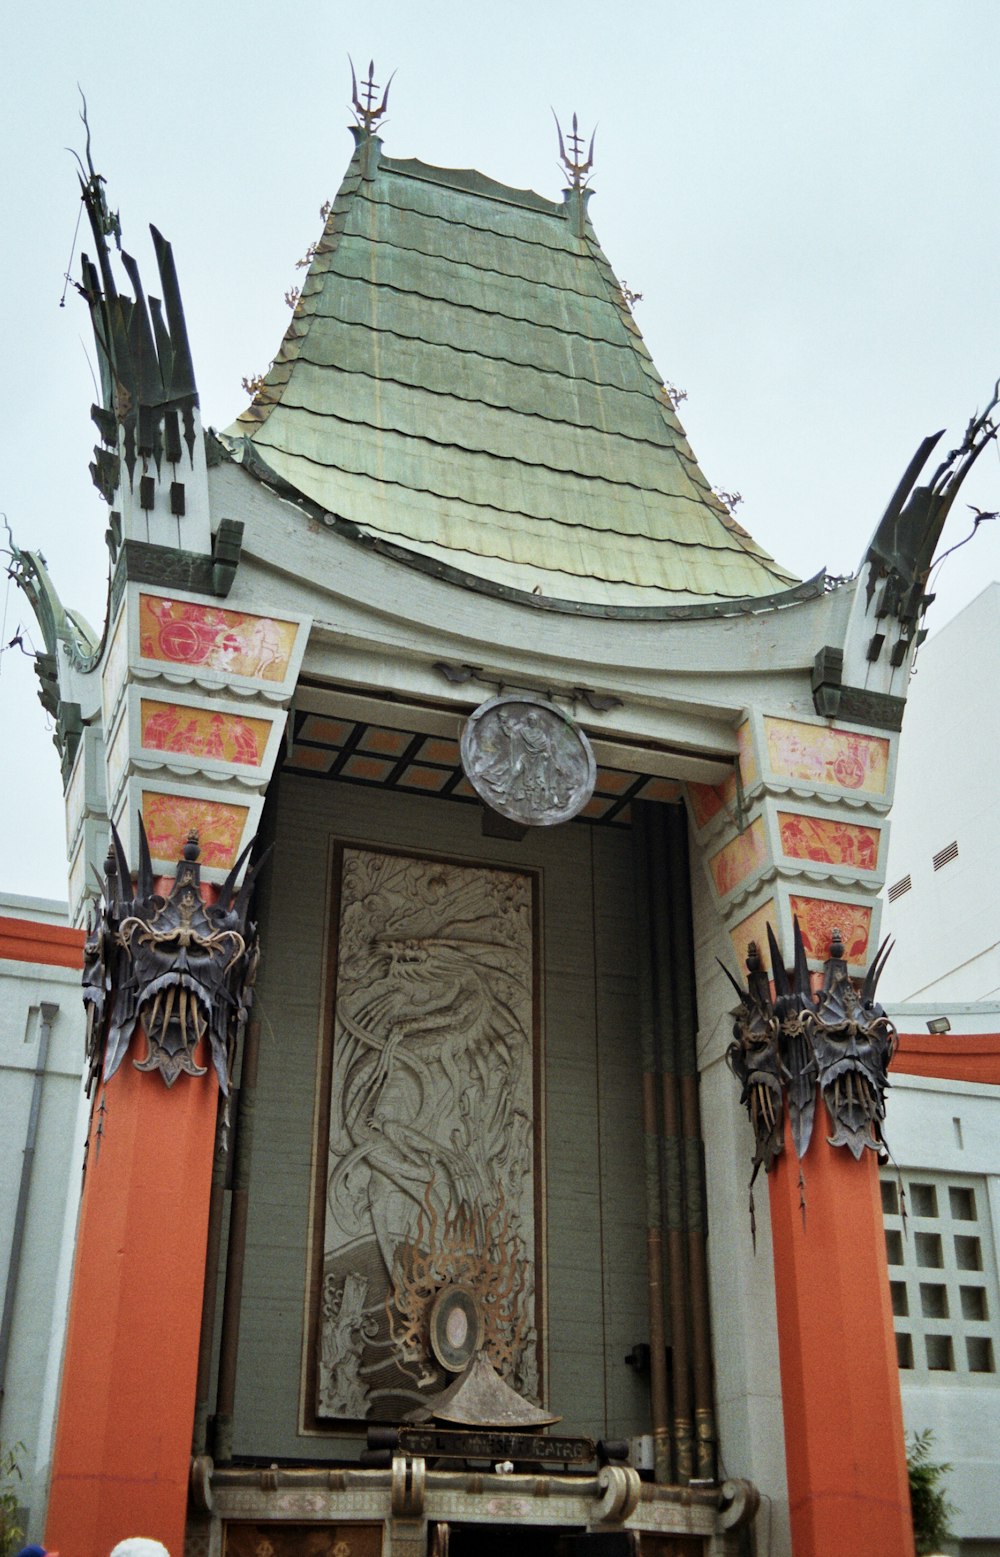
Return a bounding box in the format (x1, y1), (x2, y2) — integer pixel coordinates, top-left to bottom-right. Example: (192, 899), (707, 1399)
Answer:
(220, 438), (827, 621)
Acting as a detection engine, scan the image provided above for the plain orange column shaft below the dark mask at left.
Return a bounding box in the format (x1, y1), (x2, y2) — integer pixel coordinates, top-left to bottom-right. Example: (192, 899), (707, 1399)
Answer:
(45, 1002), (218, 1557)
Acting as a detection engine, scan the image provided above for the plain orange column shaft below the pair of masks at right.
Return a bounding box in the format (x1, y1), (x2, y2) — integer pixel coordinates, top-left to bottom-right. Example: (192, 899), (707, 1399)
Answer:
(768, 1133), (913, 1557)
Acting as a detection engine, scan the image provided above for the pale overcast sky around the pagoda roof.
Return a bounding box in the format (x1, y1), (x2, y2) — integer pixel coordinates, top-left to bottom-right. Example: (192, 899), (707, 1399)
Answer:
(0, 0), (1000, 897)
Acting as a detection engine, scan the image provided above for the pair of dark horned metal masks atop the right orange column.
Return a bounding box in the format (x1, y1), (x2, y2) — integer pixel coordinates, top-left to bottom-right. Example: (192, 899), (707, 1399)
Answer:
(724, 920), (897, 1185)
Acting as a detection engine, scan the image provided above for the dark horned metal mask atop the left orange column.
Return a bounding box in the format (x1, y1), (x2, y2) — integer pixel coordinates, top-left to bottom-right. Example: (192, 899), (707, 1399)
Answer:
(83, 816), (263, 1096)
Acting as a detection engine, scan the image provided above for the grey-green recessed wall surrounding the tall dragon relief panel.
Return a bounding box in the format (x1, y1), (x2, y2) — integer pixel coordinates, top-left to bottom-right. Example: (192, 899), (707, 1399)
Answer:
(227, 777), (648, 1457)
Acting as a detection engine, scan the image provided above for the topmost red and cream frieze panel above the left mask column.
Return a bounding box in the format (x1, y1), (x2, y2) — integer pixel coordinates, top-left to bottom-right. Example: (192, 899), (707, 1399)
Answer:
(139, 593), (299, 682)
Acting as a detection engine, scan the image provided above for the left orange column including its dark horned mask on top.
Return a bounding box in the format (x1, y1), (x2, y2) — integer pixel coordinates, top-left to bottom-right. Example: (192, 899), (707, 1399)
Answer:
(47, 824), (259, 1557)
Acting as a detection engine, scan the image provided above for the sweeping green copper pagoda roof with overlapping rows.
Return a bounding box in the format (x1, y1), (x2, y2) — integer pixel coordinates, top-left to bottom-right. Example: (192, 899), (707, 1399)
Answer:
(223, 129), (796, 610)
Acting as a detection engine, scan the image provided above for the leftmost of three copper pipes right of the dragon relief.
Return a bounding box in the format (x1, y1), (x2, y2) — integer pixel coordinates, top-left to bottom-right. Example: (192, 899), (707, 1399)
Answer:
(632, 805), (671, 1484)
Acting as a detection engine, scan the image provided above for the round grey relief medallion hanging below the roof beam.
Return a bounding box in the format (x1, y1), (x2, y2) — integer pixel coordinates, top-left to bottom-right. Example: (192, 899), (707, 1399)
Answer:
(461, 691), (597, 827)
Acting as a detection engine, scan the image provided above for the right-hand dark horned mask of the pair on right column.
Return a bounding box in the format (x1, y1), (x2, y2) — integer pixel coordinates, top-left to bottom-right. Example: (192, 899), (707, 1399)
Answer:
(796, 925), (897, 1160)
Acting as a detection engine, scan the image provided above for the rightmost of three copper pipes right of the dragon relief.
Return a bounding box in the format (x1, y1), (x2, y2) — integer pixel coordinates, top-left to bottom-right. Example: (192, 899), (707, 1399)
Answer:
(667, 807), (717, 1481)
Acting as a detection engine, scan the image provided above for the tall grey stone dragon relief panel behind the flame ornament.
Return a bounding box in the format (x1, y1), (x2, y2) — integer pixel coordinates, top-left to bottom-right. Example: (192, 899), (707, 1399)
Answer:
(316, 847), (537, 1418)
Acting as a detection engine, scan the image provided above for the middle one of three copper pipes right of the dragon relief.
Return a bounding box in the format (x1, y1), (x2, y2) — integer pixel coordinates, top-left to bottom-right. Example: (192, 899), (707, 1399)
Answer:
(650, 807), (695, 1482)
